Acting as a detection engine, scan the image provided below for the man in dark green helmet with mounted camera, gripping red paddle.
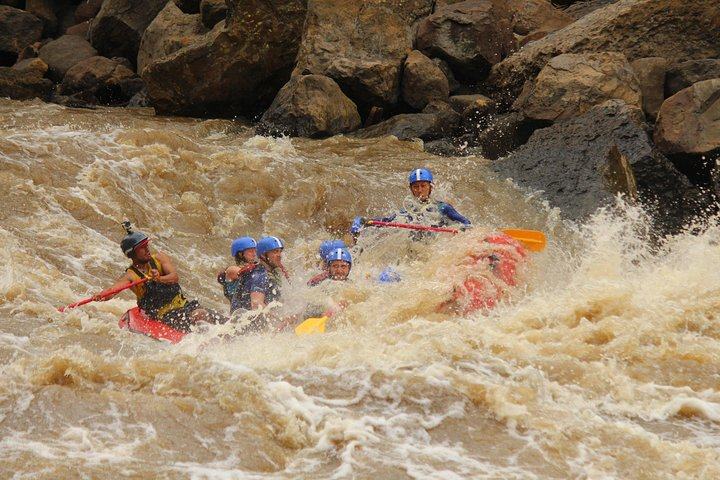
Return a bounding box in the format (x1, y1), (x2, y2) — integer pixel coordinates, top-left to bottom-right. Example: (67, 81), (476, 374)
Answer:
(93, 222), (228, 332)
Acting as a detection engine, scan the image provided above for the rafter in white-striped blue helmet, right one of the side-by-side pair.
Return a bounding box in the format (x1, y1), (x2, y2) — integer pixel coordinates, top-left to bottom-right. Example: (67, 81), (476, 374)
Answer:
(230, 237), (287, 334)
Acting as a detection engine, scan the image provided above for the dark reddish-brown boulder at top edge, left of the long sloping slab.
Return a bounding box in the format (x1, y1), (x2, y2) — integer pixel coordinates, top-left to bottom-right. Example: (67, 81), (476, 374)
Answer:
(416, 0), (515, 83)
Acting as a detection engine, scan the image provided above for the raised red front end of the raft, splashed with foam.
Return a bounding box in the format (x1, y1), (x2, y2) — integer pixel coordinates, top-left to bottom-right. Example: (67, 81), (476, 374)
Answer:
(437, 232), (529, 315)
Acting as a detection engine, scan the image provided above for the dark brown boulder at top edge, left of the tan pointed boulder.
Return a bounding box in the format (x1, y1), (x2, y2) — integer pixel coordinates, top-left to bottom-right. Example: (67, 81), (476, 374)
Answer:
(88, 0), (168, 63)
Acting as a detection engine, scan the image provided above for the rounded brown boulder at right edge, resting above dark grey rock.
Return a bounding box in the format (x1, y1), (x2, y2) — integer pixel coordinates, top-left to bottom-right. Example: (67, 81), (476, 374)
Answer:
(654, 78), (720, 154)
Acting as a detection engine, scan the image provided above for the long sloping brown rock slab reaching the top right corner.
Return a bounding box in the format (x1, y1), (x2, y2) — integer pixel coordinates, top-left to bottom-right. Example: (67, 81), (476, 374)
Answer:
(486, 0), (720, 105)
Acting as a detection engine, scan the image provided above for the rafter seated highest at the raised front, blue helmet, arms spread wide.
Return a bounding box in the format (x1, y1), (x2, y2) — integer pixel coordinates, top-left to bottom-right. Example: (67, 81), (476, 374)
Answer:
(350, 168), (471, 238)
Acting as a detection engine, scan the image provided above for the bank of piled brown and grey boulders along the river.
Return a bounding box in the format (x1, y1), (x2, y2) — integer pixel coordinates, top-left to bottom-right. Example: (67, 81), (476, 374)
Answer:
(0, 0), (720, 232)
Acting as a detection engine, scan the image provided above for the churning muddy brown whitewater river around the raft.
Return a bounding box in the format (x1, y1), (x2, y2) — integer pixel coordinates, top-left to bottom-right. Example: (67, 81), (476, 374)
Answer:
(0, 100), (720, 479)
